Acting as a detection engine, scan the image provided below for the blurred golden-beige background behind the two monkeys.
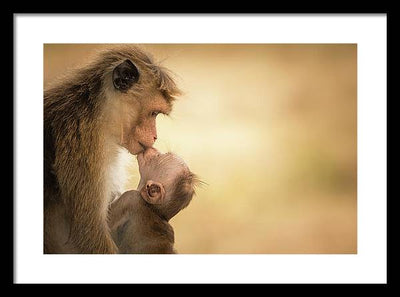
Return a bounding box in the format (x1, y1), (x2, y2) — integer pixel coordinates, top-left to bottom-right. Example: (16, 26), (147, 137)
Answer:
(44, 44), (357, 254)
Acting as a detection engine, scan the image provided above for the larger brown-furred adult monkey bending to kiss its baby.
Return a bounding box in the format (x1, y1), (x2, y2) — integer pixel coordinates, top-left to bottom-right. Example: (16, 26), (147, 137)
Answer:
(44, 46), (179, 253)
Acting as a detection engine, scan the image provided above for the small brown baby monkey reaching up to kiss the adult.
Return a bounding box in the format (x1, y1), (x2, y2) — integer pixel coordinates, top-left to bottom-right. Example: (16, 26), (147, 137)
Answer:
(109, 148), (198, 254)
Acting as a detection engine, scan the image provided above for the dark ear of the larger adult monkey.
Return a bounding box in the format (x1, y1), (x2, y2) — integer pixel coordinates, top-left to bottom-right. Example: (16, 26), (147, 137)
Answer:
(113, 59), (139, 92)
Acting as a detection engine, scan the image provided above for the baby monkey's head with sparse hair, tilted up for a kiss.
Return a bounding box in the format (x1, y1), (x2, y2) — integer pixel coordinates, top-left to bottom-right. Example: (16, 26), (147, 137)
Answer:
(137, 148), (198, 220)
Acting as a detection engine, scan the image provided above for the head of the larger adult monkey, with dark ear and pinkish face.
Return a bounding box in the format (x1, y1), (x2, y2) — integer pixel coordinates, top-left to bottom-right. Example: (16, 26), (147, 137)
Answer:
(103, 46), (180, 155)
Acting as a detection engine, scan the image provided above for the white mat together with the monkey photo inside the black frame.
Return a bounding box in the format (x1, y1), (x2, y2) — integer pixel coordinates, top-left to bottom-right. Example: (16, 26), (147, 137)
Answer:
(14, 14), (387, 283)
